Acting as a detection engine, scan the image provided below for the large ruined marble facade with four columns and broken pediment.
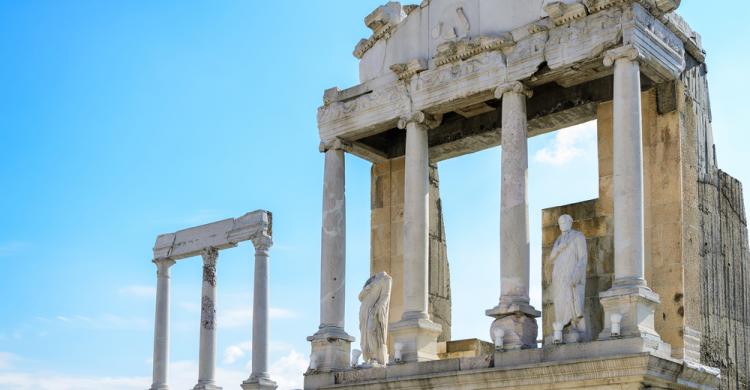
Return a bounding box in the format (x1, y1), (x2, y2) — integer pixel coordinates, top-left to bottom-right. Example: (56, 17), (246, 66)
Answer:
(305, 0), (750, 389)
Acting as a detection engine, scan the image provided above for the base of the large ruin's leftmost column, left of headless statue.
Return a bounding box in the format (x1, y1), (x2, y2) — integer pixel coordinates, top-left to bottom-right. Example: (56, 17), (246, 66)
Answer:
(307, 327), (355, 372)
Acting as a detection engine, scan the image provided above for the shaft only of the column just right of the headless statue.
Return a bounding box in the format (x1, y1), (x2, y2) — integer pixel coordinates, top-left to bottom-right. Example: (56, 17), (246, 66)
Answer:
(402, 121), (430, 319)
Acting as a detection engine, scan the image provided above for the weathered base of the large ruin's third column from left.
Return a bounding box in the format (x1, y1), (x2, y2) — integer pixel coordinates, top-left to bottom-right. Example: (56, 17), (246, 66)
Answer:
(485, 298), (542, 350)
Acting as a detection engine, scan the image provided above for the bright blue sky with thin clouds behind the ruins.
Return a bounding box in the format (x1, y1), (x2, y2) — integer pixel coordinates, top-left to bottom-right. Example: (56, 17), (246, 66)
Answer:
(0, 0), (750, 390)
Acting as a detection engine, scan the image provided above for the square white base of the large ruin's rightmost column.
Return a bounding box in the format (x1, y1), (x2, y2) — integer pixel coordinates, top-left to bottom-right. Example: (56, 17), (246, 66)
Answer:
(599, 282), (661, 347)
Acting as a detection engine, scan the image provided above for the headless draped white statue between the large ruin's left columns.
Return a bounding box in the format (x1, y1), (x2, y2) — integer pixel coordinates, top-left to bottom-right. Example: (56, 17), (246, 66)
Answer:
(359, 272), (393, 365)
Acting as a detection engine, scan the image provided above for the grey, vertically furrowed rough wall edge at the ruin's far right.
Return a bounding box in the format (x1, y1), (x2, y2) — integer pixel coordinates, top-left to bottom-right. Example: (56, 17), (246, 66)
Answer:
(678, 61), (750, 389)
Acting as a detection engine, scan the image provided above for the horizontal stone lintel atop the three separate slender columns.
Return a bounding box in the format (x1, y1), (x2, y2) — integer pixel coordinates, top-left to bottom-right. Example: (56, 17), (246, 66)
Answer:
(154, 210), (272, 260)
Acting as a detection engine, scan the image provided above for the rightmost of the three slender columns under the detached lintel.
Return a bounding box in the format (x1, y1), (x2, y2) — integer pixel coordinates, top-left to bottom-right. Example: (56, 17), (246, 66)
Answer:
(242, 235), (277, 390)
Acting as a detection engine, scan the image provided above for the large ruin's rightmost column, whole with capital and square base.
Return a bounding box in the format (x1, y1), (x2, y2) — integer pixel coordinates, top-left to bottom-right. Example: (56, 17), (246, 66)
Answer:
(599, 46), (659, 340)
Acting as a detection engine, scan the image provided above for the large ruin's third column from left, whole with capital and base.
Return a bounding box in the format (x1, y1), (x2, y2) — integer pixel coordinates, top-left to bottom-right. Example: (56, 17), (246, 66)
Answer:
(486, 82), (541, 349)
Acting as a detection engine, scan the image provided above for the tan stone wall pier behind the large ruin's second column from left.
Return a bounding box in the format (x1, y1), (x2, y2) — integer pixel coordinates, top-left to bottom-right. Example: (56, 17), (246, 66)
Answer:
(370, 157), (451, 341)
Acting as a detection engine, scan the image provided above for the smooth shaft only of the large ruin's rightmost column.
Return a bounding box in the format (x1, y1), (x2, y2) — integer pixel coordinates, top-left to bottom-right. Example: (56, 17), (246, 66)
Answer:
(612, 57), (645, 285)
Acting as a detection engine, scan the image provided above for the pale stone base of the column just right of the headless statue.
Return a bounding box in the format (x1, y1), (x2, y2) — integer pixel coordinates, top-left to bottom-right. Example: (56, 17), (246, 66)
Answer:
(388, 313), (443, 363)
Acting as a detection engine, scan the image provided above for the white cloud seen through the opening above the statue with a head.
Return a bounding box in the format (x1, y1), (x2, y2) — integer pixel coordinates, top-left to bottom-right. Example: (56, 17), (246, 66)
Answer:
(534, 121), (597, 165)
